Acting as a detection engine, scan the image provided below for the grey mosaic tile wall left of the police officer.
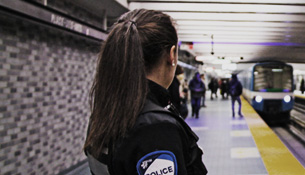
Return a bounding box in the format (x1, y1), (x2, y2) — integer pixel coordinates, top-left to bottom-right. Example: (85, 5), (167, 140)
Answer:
(0, 11), (100, 175)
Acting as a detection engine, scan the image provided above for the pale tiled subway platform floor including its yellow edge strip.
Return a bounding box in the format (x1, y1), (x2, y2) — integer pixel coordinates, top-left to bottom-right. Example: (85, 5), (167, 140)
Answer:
(68, 94), (305, 175)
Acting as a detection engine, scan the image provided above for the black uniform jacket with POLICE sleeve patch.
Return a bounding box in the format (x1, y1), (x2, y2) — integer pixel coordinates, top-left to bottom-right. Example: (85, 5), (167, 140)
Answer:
(87, 81), (207, 175)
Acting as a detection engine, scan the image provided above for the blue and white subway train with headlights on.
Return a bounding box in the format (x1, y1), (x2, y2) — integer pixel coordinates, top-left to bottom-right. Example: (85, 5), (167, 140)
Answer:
(239, 61), (294, 123)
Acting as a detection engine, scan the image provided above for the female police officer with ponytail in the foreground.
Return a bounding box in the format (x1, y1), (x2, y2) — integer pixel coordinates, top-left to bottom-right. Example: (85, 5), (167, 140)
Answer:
(84, 9), (207, 175)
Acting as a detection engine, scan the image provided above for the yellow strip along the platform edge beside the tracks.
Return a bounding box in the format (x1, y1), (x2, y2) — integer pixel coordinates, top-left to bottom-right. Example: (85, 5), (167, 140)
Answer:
(242, 98), (305, 175)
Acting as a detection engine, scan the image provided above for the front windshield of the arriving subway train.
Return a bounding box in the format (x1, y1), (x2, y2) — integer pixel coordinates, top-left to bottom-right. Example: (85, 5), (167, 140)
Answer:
(254, 65), (292, 92)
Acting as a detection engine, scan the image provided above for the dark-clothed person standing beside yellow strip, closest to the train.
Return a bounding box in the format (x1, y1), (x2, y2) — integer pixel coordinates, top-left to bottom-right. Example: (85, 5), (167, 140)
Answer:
(229, 74), (243, 117)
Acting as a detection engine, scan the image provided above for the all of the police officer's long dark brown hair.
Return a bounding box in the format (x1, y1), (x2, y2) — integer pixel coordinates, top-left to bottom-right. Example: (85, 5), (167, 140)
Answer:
(84, 9), (178, 157)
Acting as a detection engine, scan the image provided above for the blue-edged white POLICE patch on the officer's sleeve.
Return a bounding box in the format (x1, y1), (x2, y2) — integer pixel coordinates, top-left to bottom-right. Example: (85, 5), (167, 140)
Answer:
(137, 151), (178, 175)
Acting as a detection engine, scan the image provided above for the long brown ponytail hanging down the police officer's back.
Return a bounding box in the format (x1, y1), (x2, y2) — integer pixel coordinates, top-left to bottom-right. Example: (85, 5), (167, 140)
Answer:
(85, 17), (148, 157)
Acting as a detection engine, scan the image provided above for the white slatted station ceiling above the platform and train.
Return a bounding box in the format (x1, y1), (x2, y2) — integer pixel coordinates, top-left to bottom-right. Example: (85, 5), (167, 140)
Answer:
(72, 0), (305, 63)
